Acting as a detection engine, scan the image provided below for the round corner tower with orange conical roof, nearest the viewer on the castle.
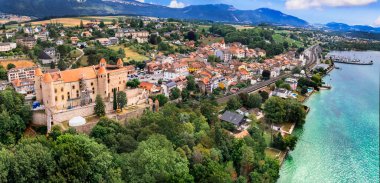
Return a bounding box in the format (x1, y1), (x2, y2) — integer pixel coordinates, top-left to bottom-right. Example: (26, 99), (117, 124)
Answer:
(42, 73), (55, 107)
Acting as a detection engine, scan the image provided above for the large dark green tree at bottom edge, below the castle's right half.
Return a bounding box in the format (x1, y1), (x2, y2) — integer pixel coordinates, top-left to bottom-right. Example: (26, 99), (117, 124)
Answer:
(53, 134), (121, 182)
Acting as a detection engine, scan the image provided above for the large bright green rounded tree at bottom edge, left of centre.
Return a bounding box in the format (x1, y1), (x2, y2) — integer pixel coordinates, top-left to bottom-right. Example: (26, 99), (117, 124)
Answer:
(122, 135), (193, 182)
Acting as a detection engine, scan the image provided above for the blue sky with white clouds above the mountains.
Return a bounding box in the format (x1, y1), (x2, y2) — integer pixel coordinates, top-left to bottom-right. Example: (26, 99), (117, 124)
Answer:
(137, 0), (380, 27)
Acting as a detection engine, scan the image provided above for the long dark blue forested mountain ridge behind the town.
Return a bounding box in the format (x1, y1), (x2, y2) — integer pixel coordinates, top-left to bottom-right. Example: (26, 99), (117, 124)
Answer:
(0, 0), (308, 27)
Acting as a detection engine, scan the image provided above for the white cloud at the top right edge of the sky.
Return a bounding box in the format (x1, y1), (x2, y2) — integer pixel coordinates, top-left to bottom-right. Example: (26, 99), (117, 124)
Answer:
(285, 0), (377, 9)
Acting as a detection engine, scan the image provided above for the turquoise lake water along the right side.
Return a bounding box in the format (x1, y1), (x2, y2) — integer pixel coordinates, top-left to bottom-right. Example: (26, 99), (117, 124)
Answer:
(278, 52), (380, 183)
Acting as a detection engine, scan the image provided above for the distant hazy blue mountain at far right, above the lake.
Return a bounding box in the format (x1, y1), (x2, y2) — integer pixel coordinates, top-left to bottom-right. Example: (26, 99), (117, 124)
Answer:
(324, 22), (380, 33)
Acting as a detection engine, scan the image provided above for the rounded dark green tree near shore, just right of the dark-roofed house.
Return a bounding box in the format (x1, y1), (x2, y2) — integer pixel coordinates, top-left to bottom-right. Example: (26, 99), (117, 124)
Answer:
(264, 97), (286, 123)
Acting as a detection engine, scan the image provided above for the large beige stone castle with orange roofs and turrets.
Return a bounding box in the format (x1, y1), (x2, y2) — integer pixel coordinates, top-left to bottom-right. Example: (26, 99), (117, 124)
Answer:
(34, 59), (135, 112)
